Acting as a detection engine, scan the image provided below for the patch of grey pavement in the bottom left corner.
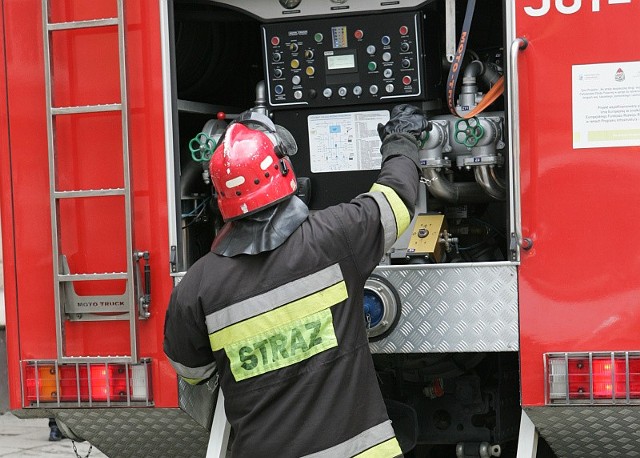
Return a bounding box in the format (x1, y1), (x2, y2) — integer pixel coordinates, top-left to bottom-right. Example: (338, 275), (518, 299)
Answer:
(0, 412), (107, 458)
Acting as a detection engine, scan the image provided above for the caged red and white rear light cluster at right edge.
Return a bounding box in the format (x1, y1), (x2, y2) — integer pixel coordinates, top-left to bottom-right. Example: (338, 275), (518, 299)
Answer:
(545, 352), (640, 404)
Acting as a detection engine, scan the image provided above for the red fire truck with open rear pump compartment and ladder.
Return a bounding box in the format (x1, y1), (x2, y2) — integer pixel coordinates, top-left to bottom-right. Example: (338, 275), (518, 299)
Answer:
(0, 0), (640, 458)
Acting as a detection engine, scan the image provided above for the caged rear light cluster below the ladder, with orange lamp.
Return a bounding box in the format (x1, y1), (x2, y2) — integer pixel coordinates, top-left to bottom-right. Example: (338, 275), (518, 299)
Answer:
(22, 361), (152, 407)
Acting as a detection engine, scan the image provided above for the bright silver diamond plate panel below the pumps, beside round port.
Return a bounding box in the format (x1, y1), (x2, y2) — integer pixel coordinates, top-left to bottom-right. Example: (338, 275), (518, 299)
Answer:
(370, 263), (518, 353)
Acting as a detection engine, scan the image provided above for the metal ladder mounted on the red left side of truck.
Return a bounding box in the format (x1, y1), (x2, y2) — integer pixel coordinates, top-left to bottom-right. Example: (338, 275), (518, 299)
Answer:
(42, 0), (149, 363)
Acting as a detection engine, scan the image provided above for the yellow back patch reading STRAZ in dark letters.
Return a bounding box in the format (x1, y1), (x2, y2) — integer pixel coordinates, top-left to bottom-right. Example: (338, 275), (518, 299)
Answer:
(224, 309), (338, 382)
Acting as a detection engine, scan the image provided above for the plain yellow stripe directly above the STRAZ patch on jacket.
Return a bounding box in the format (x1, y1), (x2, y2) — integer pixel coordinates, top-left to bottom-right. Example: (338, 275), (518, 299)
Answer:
(209, 281), (348, 351)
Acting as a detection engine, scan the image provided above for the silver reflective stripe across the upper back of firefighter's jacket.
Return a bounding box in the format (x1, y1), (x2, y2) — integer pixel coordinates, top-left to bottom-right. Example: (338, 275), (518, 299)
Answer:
(206, 264), (343, 334)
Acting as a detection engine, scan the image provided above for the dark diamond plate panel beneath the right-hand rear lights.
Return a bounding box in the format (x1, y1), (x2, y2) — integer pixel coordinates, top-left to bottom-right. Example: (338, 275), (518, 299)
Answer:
(525, 406), (640, 458)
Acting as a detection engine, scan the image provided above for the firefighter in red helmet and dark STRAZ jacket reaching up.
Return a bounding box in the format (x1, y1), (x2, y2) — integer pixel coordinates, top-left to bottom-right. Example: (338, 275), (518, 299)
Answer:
(164, 105), (428, 458)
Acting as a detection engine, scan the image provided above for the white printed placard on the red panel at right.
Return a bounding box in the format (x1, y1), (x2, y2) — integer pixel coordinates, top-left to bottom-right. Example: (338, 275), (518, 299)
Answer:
(572, 62), (640, 148)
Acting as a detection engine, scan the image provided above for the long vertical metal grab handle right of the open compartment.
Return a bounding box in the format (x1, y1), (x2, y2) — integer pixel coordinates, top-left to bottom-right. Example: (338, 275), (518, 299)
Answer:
(507, 38), (533, 260)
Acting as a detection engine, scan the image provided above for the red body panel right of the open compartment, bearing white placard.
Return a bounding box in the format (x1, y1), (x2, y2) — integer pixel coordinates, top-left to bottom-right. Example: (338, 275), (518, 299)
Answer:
(515, 0), (640, 406)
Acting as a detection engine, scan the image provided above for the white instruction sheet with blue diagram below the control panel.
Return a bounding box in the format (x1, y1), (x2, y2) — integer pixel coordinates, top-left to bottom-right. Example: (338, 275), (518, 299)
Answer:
(307, 110), (389, 173)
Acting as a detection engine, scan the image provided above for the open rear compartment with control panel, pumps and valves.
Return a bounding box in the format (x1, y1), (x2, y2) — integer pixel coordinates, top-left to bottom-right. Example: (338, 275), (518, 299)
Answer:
(164, 0), (520, 457)
